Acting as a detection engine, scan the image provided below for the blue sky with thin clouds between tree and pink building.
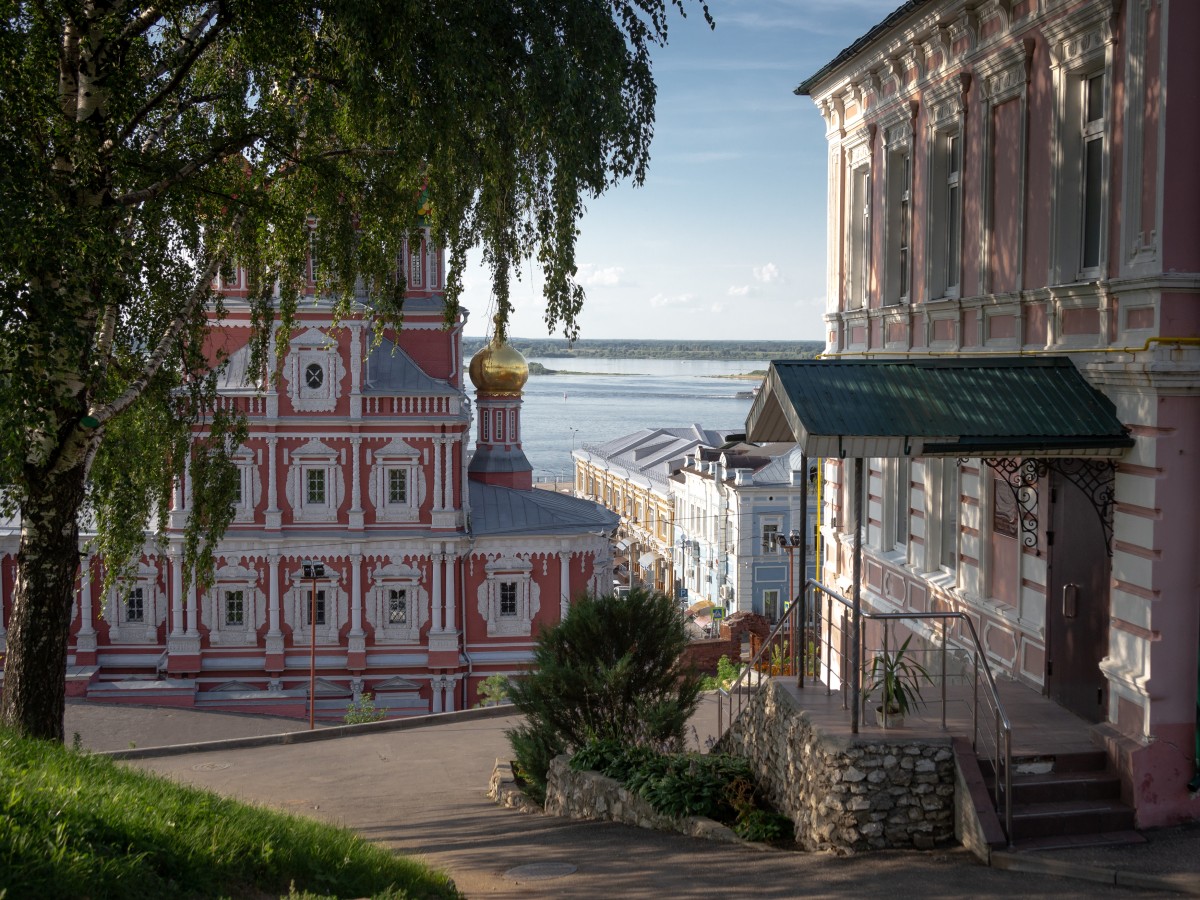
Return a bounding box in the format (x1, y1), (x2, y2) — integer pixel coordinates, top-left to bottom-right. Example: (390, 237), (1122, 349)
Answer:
(463, 0), (899, 340)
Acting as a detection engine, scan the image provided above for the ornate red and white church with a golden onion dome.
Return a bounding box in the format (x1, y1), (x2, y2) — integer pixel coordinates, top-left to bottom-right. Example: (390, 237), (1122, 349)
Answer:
(0, 241), (617, 721)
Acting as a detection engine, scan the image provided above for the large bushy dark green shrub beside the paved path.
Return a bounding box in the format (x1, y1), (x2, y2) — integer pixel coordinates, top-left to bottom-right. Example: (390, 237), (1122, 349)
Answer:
(509, 588), (701, 801)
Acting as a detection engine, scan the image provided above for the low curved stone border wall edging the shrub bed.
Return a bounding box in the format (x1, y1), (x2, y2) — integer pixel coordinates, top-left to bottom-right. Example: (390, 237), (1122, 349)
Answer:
(546, 756), (738, 841)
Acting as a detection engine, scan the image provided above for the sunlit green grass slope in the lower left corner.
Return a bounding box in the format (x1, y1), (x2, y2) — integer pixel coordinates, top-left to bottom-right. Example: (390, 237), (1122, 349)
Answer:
(0, 730), (460, 900)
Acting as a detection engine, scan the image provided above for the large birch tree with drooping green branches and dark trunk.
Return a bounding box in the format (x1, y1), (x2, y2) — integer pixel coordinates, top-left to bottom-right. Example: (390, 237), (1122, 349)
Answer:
(0, 0), (712, 739)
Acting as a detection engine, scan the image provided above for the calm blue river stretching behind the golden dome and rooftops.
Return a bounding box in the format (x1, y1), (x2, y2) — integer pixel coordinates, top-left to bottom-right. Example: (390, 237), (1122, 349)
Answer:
(511, 358), (769, 480)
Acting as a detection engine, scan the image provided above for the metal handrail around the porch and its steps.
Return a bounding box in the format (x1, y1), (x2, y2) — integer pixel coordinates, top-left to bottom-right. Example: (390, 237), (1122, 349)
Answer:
(716, 578), (1013, 840)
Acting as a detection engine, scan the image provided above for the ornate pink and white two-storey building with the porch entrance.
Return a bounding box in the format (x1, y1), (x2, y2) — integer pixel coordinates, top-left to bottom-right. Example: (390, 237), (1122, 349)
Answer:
(750, 0), (1200, 826)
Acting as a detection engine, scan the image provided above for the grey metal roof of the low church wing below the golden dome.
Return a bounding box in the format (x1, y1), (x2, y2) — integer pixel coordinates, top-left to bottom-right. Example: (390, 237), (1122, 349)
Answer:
(467, 481), (620, 535)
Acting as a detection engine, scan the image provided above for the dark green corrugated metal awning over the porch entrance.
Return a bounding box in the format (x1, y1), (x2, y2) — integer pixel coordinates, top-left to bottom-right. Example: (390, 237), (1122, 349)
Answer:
(746, 356), (1133, 458)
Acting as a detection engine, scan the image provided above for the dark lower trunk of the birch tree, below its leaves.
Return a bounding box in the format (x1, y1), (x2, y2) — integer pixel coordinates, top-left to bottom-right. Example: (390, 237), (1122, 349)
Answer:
(0, 461), (85, 740)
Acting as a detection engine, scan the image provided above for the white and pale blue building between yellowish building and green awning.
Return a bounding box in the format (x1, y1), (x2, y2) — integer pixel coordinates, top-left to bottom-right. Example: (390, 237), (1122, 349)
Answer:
(671, 443), (816, 622)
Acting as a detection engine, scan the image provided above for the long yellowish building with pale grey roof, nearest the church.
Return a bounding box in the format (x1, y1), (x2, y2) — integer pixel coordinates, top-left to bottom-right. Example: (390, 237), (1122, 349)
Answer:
(571, 425), (726, 595)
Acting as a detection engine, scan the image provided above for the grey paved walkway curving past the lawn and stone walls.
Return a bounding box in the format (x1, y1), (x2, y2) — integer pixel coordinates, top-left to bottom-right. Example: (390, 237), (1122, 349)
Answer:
(66, 703), (1200, 900)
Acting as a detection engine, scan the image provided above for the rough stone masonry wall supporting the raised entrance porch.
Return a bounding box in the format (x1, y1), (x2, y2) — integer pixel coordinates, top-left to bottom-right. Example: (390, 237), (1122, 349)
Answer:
(716, 682), (954, 852)
